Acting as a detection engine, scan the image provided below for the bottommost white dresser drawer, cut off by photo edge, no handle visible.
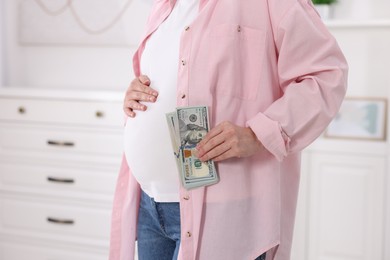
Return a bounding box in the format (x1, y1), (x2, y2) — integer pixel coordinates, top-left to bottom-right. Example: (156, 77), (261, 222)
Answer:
(0, 242), (108, 260)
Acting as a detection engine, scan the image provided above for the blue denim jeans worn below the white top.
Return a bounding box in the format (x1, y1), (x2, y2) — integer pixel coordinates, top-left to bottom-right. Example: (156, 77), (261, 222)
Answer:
(137, 191), (265, 260)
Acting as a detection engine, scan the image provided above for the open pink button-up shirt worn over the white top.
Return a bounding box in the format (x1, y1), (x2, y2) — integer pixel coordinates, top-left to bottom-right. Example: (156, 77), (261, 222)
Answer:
(110, 0), (347, 260)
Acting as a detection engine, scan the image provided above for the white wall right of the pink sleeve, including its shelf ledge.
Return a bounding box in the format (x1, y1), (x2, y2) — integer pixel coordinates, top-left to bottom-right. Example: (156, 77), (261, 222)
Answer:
(329, 0), (390, 97)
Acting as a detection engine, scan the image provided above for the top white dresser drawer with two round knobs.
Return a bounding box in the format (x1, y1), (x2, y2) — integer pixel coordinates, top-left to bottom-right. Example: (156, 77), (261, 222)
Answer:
(0, 97), (124, 127)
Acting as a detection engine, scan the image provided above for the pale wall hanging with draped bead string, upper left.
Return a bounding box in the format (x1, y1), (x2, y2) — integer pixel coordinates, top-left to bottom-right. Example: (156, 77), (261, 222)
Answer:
(18, 0), (152, 46)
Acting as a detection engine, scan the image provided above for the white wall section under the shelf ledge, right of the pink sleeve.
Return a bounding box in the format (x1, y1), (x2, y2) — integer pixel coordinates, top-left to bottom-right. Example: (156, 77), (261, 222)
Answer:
(330, 26), (390, 97)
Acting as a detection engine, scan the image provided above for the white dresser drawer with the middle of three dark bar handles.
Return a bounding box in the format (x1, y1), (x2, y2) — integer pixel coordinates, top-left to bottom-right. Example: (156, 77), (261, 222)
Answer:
(0, 162), (117, 199)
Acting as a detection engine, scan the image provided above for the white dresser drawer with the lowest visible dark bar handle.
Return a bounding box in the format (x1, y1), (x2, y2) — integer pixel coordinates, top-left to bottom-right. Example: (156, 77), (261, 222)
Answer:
(0, 198), (111, 242)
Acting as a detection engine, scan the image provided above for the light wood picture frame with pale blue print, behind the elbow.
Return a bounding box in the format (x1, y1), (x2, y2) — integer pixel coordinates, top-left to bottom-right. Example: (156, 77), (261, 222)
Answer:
(324, 97), (387, 141)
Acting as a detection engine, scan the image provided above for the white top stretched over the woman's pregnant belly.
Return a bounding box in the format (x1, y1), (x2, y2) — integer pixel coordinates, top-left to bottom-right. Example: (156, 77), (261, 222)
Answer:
(124, 0), (199, 202)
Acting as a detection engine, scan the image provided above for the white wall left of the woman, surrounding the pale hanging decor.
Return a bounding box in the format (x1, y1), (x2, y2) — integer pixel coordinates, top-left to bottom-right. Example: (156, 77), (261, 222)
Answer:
(1, 0), (151, 89)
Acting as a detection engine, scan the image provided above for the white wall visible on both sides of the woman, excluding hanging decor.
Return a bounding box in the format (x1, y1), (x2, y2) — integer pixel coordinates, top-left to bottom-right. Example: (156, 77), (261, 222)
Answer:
(1, 0), (390, 92)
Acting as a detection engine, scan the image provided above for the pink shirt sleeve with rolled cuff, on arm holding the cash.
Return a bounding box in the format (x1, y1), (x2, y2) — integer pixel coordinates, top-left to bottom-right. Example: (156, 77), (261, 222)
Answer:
(247, 0), (348, 161)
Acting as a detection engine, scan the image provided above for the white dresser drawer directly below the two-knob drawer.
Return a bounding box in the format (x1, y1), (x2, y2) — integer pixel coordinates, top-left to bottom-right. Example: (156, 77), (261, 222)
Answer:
(0, 124), (123, 159)
